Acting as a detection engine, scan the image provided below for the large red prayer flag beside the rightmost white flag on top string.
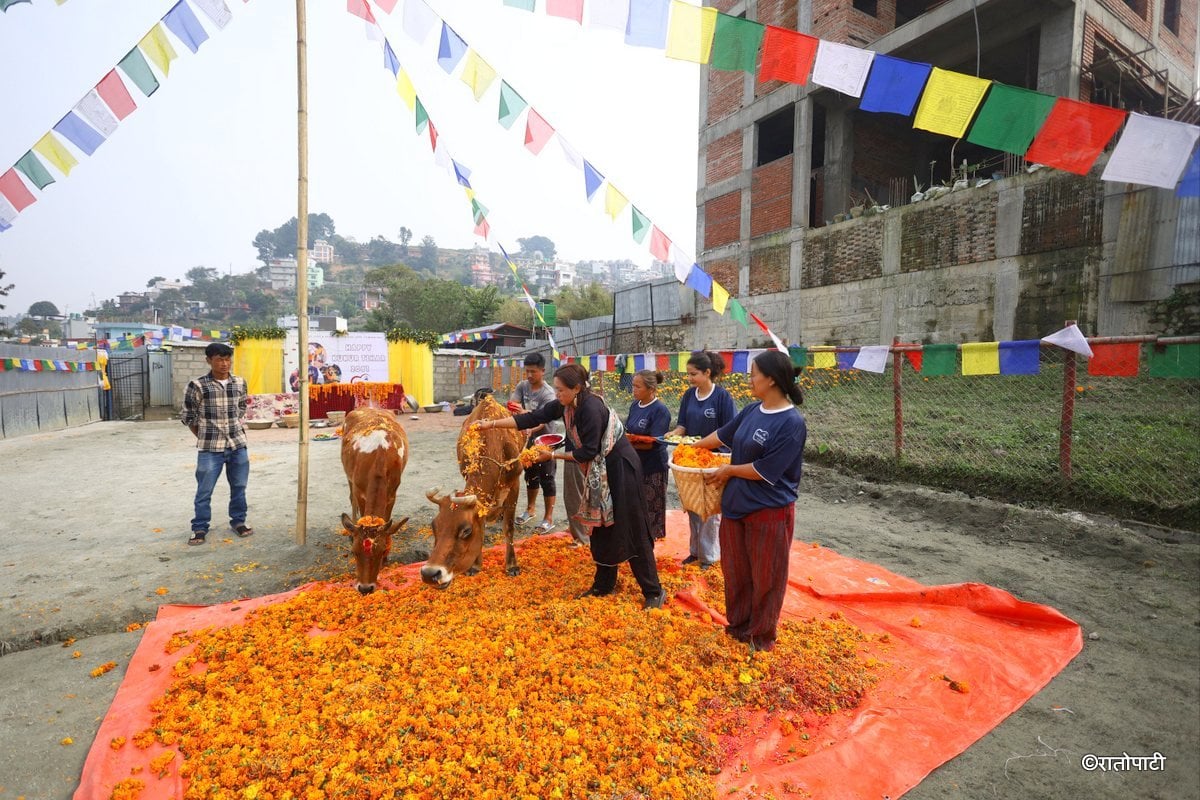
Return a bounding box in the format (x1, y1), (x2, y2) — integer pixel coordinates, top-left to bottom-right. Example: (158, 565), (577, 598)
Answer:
(1025, 97), (1126, 175)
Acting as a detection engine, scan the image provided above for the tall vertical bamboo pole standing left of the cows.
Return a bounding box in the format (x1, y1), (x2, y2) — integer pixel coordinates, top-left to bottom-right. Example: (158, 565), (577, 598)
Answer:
(295, 0), (308, 545)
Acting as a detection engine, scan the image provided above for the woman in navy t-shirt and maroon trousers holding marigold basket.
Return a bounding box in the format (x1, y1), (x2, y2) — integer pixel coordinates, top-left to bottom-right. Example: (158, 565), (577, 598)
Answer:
(697, 350), (808, 650)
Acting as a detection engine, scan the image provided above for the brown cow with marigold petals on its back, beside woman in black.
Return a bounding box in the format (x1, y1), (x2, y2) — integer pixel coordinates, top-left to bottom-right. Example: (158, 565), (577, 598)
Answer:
(421, 395), (524, 589)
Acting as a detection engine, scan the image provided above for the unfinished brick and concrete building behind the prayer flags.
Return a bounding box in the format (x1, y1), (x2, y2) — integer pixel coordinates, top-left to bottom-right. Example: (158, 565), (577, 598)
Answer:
(695, 0), (1200, 347)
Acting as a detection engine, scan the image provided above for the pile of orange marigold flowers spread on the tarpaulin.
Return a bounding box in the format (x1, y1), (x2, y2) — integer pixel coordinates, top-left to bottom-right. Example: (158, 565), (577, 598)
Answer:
(128, 539), (877, 800)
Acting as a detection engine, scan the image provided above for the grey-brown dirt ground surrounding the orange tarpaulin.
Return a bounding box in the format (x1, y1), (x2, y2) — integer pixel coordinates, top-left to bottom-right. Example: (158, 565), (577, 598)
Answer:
(0, 414), (1200, 800)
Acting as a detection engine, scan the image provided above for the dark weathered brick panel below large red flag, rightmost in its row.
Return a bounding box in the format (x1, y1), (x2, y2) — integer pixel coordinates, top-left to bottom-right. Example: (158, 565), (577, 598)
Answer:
(1021, 173), (1104, 253)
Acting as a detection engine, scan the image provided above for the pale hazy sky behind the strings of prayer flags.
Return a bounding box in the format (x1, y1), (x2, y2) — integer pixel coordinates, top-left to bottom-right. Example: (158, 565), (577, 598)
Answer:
(0, 0), (700, 314)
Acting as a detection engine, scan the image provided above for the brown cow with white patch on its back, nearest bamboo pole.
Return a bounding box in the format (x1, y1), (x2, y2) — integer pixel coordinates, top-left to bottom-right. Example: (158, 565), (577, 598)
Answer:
(342, 408), (408, 595)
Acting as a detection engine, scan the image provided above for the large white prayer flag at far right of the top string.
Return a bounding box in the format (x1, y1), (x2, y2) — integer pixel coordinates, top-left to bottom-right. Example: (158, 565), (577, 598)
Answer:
(1100, 114), (1200, 188)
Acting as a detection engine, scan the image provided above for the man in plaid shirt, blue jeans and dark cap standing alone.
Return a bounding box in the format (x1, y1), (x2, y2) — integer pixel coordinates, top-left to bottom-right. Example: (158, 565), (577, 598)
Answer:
(184, 342), (254, 545)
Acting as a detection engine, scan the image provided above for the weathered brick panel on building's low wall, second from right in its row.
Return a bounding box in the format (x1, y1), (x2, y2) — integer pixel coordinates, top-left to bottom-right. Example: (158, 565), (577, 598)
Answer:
(900, 192), (1000, 272)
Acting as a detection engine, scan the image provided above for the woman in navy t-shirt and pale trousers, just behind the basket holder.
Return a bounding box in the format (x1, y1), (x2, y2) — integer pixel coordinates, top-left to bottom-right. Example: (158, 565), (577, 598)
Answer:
(672, 350), (738, 570)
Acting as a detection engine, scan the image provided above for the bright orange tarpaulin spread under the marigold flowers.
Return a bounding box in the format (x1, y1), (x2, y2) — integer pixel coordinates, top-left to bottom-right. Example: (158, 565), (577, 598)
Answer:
(74, 511), (1082, 800)
